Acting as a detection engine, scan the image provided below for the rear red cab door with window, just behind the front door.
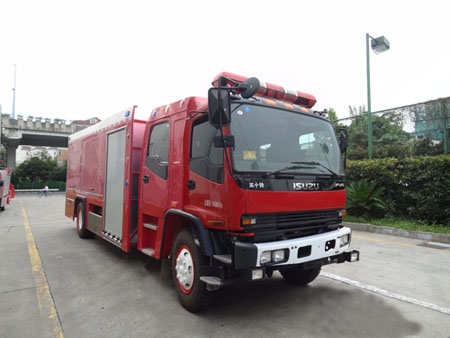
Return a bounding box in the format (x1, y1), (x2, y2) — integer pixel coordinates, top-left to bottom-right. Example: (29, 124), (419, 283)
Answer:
(138, 121), (170, 257)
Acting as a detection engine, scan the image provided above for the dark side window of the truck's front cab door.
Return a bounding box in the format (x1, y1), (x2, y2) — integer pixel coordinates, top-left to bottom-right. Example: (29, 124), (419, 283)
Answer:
(189, 119), (223, 183)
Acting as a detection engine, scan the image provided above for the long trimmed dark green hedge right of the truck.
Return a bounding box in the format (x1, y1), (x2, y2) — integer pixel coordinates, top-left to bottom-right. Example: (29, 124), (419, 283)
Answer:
(346, 155), (450, 226)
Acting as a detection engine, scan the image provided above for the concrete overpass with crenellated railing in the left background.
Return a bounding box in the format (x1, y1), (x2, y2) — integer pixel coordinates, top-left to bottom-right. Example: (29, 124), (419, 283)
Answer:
(0, 114), (99, 169)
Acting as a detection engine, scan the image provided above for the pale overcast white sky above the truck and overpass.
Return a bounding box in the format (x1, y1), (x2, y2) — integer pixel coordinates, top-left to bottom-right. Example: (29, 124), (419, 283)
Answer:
(0, 0), (450, 121)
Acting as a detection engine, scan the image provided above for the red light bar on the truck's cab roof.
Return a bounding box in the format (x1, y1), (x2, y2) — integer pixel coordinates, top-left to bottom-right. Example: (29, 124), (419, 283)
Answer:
(212, 72), (317, 108)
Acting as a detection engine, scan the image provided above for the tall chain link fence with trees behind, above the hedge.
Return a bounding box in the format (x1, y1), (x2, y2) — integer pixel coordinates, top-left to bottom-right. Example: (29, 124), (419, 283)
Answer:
(334, 97), (450, 160)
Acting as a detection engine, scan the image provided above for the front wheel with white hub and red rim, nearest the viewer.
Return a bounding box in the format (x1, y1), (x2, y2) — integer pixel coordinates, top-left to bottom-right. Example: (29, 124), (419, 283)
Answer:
(172, 229), (212, 312)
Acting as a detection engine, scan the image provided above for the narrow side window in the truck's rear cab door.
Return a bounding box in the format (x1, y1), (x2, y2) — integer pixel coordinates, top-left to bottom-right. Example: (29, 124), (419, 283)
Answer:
(145, 122), (170, 180)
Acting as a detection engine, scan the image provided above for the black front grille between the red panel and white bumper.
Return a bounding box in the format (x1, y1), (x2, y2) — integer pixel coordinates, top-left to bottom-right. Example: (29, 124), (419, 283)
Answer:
(244, 210), (342, 242)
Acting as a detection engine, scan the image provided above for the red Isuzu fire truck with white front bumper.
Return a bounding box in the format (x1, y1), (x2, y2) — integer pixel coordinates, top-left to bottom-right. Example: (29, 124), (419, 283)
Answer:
(65, 72), (359, 312)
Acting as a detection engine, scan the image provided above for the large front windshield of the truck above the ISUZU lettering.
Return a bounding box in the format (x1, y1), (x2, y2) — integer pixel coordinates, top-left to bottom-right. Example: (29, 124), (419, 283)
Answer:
(230, 104), (344, 175)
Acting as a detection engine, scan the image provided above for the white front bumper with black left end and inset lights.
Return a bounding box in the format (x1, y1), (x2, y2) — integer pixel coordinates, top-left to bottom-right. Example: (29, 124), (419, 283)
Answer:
(232, 227), (359, 269)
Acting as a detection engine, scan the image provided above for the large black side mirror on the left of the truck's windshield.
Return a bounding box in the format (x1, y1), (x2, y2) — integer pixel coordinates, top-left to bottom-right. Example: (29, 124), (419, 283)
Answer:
(208, 88), (231, 128)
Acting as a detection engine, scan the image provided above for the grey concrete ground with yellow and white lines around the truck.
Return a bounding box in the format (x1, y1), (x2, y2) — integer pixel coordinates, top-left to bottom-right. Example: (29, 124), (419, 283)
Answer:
(0, 194), (450, 338)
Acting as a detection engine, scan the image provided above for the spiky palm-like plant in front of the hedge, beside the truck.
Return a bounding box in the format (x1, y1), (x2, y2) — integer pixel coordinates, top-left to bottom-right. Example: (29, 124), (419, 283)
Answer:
(347, 179), (386, 217)
